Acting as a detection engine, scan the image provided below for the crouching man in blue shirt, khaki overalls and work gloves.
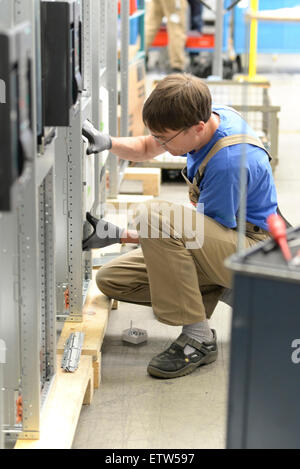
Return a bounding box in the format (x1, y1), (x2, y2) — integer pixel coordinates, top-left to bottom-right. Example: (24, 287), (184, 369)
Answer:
(83, 74), (277, 378)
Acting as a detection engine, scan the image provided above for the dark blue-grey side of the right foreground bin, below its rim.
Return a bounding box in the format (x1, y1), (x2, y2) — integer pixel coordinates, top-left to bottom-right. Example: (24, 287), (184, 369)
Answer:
(227, 272), (300, 449)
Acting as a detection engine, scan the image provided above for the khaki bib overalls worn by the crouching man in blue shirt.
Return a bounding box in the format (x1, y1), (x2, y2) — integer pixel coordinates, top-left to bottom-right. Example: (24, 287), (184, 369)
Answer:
(96, 135), (269, 326)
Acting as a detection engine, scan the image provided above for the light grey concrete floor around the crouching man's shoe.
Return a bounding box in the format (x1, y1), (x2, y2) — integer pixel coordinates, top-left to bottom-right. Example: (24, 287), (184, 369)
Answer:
(73, 73), (300, 449)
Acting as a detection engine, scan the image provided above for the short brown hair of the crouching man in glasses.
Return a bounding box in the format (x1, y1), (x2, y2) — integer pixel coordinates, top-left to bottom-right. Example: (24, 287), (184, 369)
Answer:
(143, 73), (212, 132)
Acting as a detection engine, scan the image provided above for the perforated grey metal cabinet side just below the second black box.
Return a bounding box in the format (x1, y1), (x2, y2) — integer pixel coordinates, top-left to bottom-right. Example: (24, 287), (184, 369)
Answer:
(55, 98), (91, 308)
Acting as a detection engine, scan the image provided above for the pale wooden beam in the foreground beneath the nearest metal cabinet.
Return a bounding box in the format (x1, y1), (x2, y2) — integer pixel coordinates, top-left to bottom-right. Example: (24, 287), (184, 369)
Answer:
(15, 355), (94, 449)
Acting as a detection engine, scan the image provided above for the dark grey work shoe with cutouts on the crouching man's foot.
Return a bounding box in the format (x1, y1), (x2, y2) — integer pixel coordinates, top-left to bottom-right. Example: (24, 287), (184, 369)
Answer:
(147, 329), (218, 378)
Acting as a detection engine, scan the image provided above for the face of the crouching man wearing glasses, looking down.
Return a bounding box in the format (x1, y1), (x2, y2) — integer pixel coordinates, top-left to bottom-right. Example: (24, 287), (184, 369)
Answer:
(152, 125), (202, 156)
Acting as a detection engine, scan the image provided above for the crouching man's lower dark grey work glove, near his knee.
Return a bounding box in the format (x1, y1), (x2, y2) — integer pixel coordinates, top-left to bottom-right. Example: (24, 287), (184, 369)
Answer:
(82, 212), (124, 251)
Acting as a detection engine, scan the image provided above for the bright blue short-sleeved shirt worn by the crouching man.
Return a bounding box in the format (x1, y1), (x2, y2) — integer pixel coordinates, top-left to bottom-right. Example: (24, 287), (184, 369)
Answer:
(186, 105), (277, 230)
